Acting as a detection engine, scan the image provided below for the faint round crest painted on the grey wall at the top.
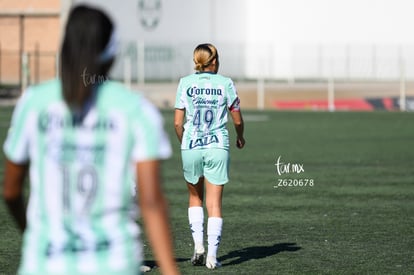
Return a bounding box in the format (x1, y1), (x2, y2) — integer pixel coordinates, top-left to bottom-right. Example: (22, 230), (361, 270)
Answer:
(138, 0), (161, 30)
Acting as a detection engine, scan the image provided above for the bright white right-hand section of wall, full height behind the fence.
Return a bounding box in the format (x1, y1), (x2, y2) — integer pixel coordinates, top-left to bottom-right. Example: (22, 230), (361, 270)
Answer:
(246, 0), (414, 78)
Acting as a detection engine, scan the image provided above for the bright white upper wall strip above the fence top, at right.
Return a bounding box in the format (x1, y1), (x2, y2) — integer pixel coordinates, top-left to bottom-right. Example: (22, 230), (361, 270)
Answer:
(246, 0), (414, 44)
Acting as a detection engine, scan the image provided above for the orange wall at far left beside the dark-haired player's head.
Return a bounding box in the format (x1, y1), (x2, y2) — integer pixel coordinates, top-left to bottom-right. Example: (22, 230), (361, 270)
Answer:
(0, 0), (61, 84)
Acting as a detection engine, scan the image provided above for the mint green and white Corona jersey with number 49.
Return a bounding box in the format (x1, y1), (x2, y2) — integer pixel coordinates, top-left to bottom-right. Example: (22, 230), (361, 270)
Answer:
(175, 73), (238, 150)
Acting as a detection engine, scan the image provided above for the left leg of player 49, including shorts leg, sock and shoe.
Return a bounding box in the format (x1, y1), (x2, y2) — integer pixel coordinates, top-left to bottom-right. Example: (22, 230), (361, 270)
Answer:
(181, 150), (205, 265)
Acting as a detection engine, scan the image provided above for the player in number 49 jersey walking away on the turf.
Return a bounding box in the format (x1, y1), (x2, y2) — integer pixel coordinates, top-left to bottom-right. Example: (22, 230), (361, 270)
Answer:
(174, 44), (245, 269)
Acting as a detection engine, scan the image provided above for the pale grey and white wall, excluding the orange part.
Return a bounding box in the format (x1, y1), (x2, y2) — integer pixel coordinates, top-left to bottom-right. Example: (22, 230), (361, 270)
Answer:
(69, 0), (414, 78)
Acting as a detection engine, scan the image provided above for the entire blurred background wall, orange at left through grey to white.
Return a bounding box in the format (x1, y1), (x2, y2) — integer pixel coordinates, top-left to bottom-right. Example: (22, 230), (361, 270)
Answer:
(0, 0), (414, 83)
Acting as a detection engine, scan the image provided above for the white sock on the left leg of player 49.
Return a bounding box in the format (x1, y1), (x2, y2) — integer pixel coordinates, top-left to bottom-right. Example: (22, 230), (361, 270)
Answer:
(188, 206), (204, 253)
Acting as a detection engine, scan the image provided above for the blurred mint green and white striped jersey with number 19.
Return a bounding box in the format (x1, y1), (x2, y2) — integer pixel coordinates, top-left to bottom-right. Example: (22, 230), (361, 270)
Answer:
(4, 80), (171, 274)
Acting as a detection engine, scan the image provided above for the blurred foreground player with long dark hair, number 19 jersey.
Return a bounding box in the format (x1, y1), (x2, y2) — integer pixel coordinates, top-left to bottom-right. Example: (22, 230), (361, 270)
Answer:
(3, 6), (178, 275)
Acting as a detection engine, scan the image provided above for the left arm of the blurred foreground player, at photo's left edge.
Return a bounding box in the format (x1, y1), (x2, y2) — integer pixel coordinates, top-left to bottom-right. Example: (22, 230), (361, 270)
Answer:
(3, 160), (29, 232)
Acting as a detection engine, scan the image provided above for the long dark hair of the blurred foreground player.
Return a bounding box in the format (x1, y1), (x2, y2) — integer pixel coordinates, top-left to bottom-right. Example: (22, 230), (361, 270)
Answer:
(60, 5), (114, 115)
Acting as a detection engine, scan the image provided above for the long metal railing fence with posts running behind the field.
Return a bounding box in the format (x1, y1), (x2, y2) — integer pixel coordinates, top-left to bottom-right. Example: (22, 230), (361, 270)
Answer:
(0, 42), (414, 110)
